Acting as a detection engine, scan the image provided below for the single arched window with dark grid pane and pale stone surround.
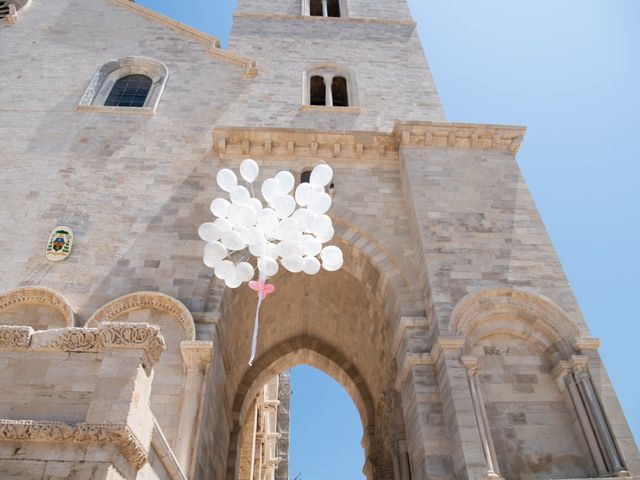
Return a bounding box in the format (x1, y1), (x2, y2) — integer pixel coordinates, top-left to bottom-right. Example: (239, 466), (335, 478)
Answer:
(77, 56), (169, 115)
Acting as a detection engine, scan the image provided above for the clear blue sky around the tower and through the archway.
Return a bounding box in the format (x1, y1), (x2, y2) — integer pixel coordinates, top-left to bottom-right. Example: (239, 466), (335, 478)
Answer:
(138, 0), (640, 480)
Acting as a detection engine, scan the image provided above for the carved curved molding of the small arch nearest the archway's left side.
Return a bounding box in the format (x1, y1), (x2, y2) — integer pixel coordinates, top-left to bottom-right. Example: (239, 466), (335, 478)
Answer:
(86, 292), (196, 340)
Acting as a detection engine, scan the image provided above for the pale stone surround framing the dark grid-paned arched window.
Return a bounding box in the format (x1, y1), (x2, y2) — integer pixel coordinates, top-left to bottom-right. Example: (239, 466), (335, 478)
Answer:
(78, 56), (169, 114)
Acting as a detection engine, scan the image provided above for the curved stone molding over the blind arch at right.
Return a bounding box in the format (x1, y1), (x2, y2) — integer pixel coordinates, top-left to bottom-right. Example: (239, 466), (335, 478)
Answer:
(449, 287), (580, 347)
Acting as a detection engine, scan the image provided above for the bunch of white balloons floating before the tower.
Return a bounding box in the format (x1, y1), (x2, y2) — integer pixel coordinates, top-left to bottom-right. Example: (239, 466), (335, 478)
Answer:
(198, 159), (343, 288)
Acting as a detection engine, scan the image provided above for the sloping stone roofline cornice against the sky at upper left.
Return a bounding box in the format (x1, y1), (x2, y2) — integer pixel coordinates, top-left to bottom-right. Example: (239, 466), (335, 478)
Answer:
(111, 0), (259, 78)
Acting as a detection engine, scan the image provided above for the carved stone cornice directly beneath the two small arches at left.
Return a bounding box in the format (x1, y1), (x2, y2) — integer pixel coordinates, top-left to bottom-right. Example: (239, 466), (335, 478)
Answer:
(0, 323), (165, 365)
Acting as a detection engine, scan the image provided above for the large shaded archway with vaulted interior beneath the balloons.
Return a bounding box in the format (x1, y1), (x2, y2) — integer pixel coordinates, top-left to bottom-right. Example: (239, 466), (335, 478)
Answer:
(195, 240), (410, 480)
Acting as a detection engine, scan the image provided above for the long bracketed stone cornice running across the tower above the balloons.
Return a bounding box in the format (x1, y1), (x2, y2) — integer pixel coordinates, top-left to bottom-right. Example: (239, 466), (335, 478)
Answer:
(213, 122), (525, 160)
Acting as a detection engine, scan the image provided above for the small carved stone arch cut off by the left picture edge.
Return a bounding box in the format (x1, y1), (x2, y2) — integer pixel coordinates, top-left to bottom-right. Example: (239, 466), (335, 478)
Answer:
(0, 287), (74, 330)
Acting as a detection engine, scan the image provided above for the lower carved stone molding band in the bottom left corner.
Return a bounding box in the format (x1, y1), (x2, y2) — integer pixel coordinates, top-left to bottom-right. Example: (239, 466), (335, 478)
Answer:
(0, 419), (147, 470)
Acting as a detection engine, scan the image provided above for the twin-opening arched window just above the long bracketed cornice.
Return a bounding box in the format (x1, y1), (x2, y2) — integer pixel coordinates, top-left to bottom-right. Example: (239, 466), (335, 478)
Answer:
(304, 64), (357, 108)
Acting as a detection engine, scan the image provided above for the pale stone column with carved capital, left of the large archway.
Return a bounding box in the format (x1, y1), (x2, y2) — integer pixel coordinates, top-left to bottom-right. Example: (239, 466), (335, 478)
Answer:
(174, 341), (213, 472)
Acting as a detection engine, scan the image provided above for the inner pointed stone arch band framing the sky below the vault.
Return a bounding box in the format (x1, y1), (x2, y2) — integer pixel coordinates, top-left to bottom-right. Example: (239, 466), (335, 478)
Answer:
(227, 335), (380, 479)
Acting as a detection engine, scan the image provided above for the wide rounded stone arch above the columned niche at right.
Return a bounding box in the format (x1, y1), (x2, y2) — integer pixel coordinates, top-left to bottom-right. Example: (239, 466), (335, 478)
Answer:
(449, 287), (580, 357)
